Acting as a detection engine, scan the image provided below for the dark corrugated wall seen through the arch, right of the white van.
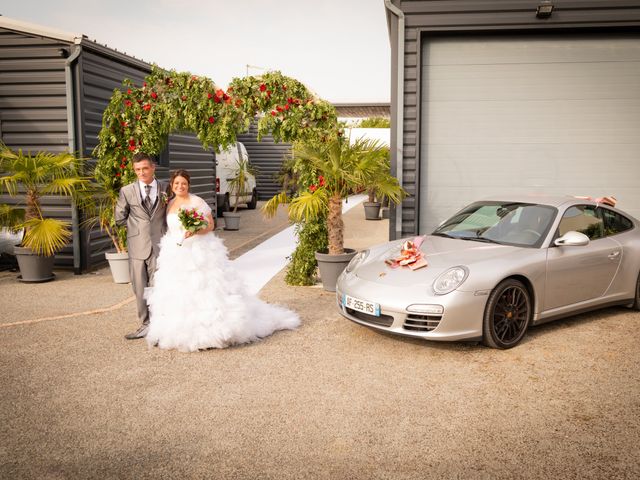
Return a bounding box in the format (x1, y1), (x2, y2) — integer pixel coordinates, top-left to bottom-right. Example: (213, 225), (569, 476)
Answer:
(238, 123), (291, 200)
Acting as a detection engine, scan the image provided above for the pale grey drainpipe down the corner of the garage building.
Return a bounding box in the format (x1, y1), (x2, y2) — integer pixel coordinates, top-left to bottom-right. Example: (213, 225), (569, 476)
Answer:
(384, 0), (404, 239)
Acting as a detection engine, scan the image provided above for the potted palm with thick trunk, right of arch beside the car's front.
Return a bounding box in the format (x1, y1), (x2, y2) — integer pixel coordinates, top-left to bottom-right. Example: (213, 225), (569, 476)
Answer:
(264, 135), (405, 291)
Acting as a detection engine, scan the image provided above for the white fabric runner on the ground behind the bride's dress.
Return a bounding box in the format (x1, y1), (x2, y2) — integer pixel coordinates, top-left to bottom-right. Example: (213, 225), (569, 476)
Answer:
(233, 195), (367, 294)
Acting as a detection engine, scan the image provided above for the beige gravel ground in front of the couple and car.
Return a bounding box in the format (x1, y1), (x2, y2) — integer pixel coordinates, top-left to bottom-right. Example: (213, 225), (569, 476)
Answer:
(0, 207), (640, 479)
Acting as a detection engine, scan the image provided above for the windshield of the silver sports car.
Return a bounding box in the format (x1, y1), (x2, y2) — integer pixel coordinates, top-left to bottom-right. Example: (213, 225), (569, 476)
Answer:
(432, 202), (557, 247)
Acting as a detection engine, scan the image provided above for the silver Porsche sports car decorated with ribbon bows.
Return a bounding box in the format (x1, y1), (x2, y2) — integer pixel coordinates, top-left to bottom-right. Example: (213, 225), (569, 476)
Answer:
(336, 196), (640, 348)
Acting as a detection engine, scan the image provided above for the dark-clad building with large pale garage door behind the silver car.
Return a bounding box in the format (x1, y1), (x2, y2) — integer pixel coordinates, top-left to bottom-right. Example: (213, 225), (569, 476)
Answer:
(385, 0), (640, 238)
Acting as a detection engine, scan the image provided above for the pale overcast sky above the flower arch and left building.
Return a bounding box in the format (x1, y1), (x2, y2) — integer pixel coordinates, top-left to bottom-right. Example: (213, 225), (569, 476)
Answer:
(0, 0), (390, 102)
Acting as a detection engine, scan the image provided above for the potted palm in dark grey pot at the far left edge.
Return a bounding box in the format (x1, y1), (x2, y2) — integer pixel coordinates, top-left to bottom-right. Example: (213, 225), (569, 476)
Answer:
(0, 143), (91, 282)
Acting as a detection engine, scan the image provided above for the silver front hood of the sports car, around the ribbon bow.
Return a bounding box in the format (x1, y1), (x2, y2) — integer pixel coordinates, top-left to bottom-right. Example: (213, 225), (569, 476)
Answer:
(354, 235), (522, 287)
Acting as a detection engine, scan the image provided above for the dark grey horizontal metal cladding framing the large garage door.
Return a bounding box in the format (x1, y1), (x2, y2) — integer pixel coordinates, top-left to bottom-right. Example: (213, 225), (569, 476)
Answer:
(387, 0), (640, 238)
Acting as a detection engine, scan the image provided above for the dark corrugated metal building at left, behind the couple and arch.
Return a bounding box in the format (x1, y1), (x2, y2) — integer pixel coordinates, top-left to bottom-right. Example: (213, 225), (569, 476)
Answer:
(0, 16), (215, 273)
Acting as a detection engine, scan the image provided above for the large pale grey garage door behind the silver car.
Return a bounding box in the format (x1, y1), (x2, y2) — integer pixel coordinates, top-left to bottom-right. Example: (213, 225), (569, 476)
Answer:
(419, 36), (640, 233)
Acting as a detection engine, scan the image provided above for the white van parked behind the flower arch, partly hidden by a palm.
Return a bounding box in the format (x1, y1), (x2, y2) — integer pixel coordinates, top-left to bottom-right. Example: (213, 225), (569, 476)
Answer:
(216, 142), (258, 216)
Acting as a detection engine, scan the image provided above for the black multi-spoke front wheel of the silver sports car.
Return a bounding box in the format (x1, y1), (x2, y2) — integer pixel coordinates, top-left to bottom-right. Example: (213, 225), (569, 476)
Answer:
(482, 278), (533, 349)
